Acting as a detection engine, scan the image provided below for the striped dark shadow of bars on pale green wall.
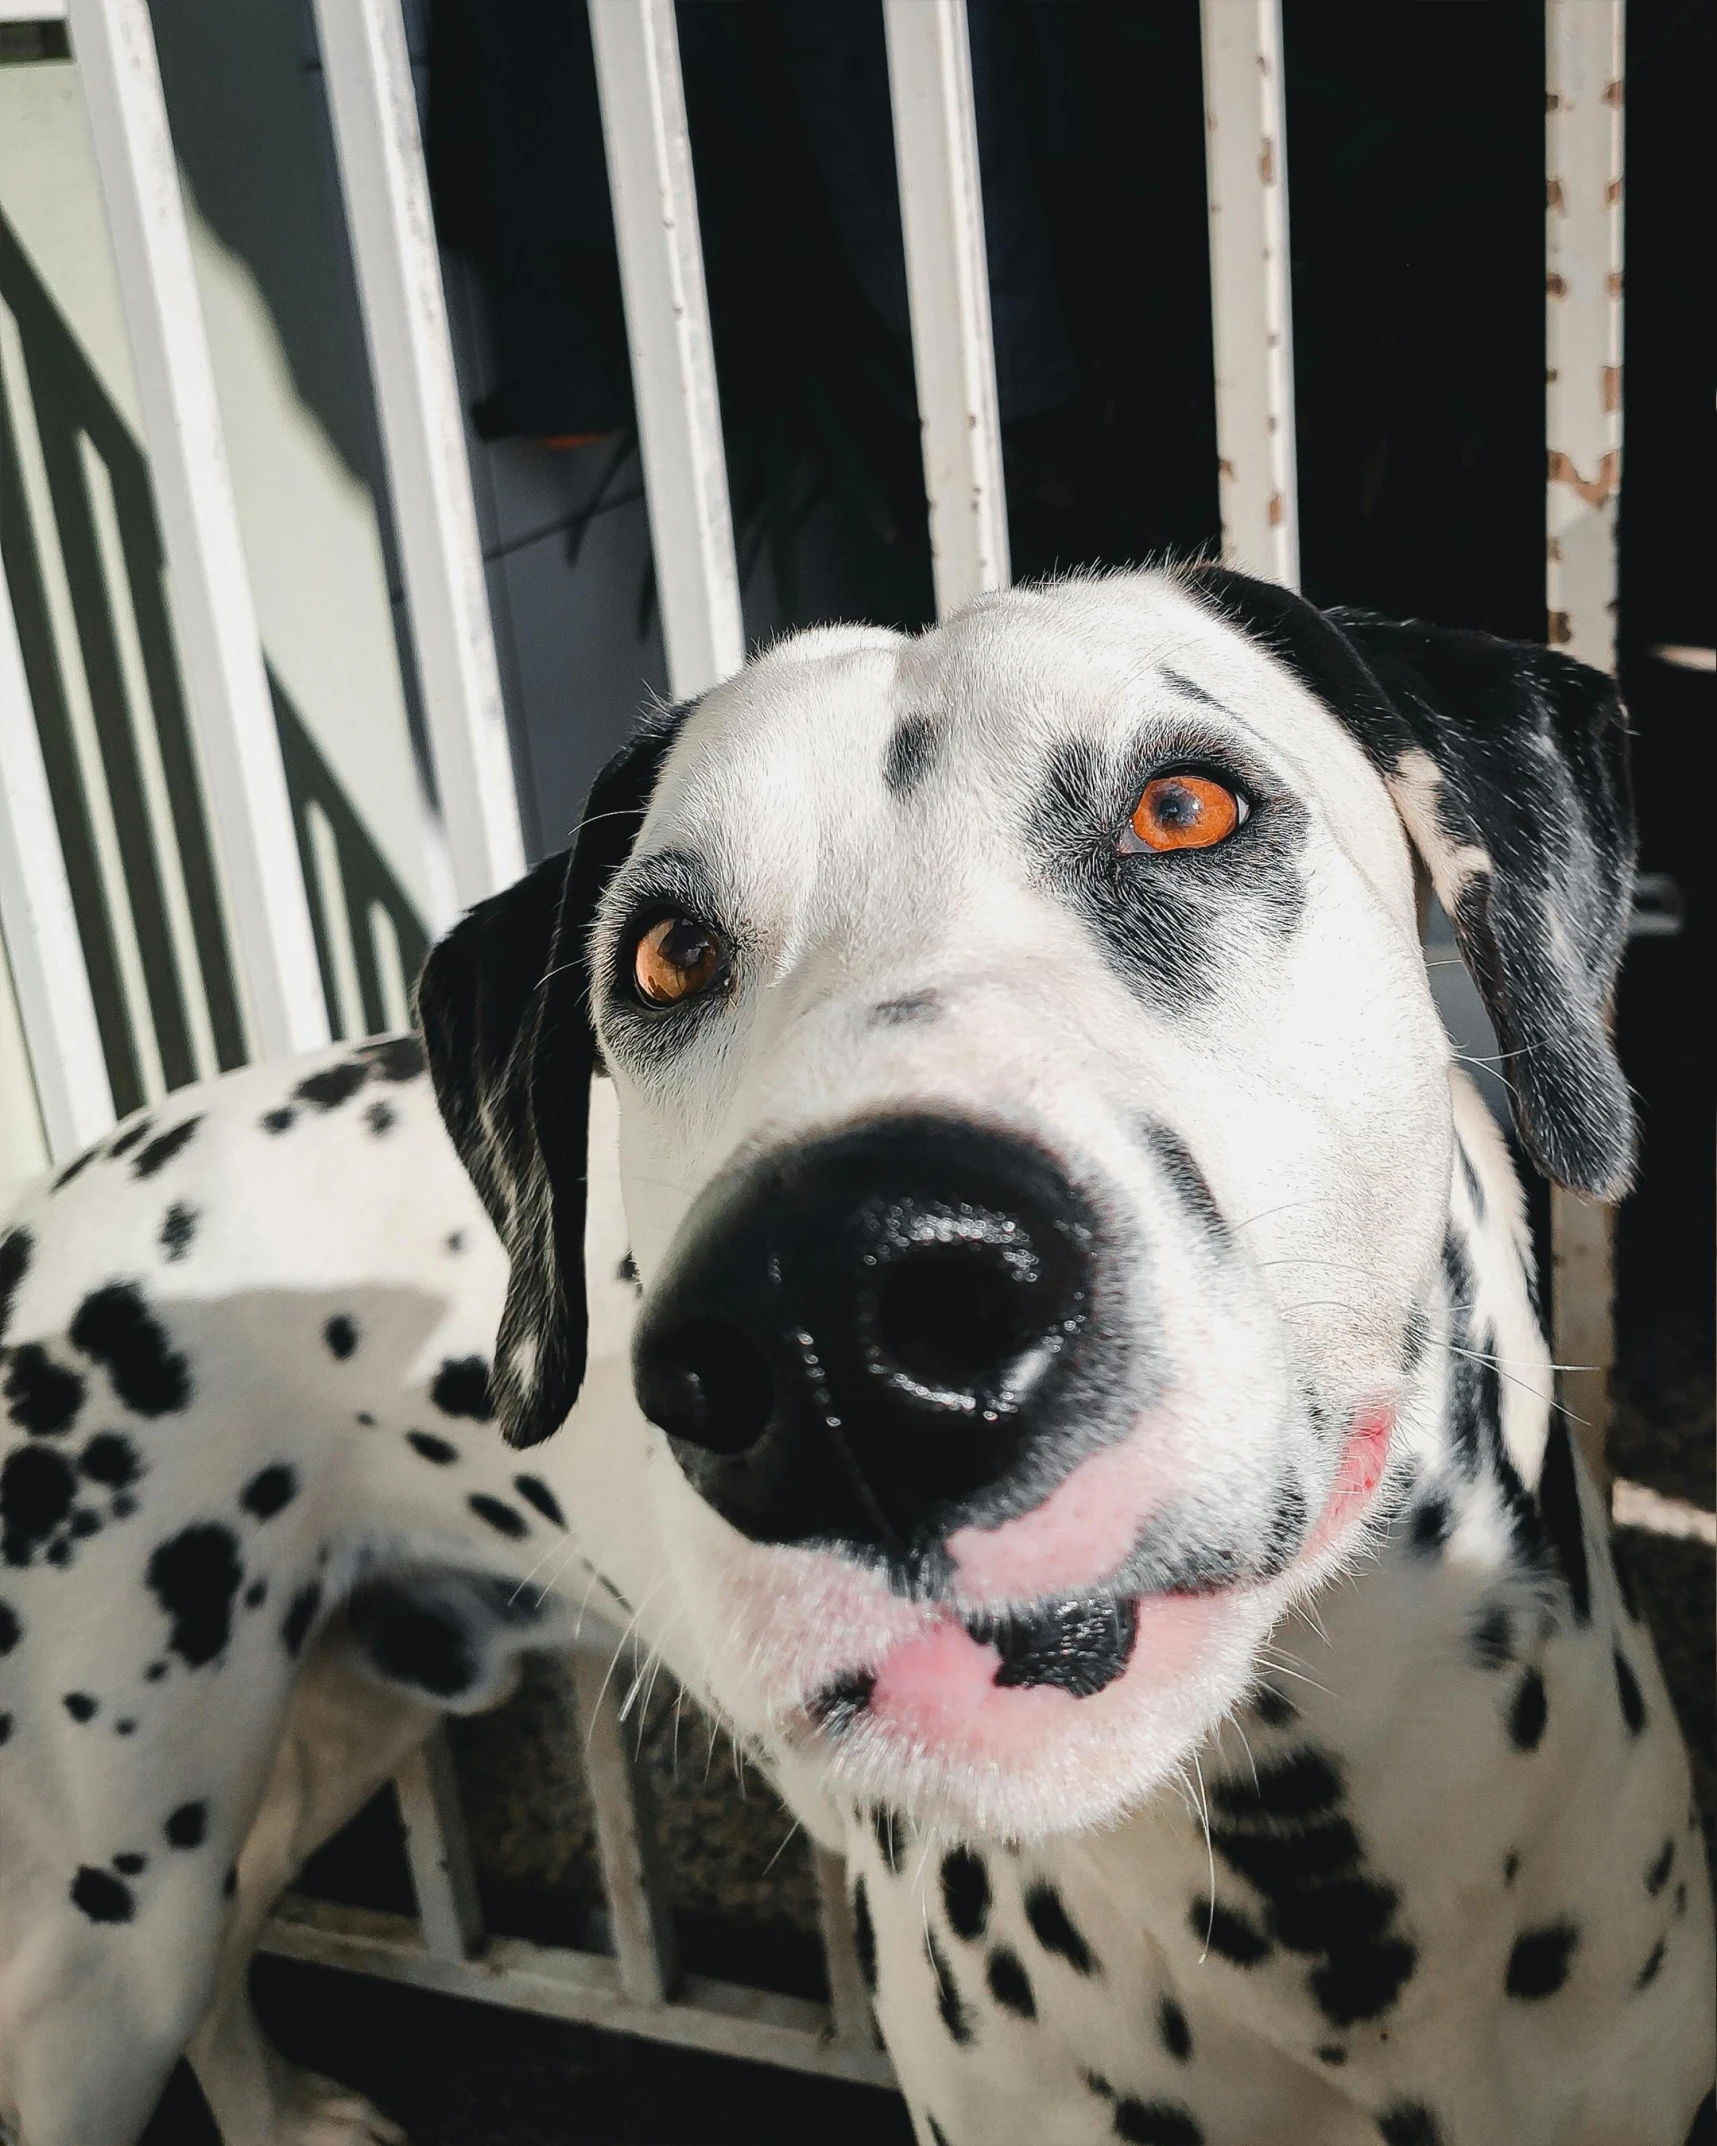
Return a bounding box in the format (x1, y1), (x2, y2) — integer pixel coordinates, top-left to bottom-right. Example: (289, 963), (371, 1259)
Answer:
(0, 217), (427, 1116)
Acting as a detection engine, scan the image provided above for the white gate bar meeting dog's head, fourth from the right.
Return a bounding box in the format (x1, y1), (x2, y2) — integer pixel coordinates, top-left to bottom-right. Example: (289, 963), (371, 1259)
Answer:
(590, 0), (745, 700)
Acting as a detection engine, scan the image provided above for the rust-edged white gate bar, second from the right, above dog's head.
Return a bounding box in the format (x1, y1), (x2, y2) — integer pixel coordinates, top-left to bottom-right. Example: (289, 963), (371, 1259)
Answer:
(1193, 0), (1301, 588)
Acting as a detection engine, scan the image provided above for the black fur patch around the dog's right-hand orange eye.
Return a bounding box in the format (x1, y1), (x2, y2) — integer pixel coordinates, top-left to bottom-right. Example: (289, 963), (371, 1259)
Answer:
(1026, 738), (1307, 1013)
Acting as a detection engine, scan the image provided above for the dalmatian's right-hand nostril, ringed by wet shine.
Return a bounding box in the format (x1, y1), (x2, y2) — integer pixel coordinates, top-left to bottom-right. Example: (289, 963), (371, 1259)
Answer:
(874, 1245), (1058, 1391)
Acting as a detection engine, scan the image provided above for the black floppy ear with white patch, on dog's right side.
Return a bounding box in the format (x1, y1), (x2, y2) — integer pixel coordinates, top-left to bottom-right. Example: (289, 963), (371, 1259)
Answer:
(1189, 567), (1635, 1200)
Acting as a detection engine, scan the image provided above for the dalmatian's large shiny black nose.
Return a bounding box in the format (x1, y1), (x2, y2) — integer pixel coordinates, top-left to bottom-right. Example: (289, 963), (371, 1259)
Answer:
(633, 1118), (1097, 1556)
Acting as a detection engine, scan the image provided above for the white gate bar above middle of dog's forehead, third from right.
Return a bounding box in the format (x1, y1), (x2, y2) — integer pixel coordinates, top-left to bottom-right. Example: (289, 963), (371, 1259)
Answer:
(882, 0), (1009, 618)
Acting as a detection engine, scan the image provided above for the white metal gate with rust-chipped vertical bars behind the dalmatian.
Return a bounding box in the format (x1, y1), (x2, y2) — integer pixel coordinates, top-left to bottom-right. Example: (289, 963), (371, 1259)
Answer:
(0, 0), (1625, 2086)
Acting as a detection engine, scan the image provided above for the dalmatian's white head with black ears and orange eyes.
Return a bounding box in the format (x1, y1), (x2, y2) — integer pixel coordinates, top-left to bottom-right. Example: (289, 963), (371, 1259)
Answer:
(421, 569), (1631, 1833)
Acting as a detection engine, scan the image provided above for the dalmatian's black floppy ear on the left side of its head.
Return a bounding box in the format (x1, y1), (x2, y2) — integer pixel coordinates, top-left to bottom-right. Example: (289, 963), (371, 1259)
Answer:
(416, 708), (687, 1446)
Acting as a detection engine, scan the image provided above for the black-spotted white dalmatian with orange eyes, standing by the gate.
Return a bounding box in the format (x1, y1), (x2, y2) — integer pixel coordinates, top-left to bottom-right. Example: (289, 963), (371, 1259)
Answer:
(0, 569), (1713, 2146)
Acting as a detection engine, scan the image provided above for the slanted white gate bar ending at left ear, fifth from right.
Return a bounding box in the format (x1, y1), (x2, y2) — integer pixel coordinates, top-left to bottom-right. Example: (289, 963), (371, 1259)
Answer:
(315, 0), (524, 914)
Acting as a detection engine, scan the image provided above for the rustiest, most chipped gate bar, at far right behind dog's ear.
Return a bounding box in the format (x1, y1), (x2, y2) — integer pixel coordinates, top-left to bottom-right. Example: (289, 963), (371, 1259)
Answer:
(1543, 0), (1625, 1474)
